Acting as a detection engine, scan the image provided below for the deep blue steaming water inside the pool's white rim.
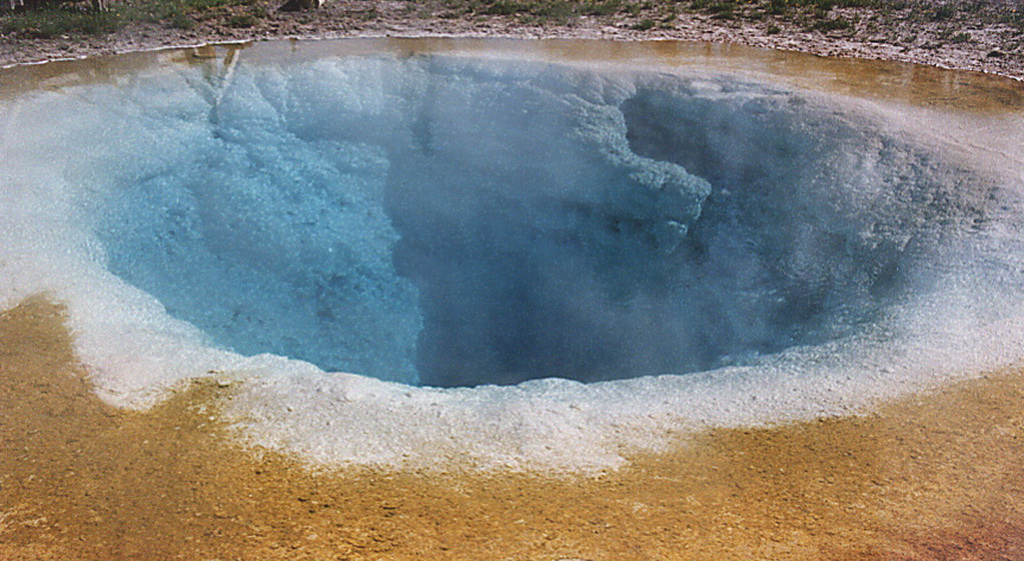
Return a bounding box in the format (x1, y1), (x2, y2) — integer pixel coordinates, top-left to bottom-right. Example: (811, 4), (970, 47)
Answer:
(88, 56), (986, 386)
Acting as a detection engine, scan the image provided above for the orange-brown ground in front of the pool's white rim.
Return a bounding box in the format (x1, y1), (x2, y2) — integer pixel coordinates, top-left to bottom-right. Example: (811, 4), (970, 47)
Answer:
(0, 298), (1024, 561)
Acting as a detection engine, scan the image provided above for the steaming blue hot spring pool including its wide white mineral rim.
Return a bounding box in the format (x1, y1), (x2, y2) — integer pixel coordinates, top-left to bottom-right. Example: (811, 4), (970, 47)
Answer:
(0, 41), (1024, 471)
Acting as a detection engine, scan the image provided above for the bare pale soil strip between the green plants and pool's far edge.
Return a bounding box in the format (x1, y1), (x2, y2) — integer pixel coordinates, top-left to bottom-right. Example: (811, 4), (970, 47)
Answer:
(0, 0), (1024, 80)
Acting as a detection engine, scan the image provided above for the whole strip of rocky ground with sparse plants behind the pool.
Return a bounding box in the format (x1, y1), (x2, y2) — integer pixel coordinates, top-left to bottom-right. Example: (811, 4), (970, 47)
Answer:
(0, 0), (1024, 80)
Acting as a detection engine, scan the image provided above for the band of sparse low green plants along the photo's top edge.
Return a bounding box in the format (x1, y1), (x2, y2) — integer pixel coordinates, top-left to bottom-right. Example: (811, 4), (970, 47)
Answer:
(0, 0), (1024, 42)
